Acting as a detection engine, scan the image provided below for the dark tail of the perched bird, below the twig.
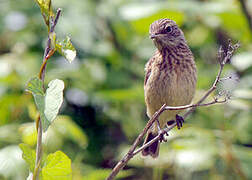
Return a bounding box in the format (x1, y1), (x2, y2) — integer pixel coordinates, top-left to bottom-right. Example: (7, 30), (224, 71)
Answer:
(142, 129), (159, 158)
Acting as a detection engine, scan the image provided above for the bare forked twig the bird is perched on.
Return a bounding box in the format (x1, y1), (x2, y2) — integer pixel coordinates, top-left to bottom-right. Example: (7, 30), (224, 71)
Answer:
(107, 42), (239, 180)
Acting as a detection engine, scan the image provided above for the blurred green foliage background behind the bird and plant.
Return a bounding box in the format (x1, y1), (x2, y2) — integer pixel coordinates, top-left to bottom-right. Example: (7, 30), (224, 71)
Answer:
(0, 0), (252, 180)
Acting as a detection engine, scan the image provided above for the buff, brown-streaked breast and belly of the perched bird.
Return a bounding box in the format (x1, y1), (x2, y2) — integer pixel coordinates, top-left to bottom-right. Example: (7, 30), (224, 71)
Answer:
(144, 54), (196, 115)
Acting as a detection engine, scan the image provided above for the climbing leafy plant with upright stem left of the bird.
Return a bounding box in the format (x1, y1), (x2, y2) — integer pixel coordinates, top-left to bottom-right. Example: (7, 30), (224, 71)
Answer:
(19, 0), (76, 180)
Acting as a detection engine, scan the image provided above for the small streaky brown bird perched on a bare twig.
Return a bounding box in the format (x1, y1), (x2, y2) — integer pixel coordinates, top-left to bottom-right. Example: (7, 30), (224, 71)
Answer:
(142, 19), (197, 158)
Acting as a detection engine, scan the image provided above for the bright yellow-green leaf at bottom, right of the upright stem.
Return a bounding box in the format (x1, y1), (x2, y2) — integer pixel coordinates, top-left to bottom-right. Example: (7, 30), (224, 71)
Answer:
(42, 151), (72, 180)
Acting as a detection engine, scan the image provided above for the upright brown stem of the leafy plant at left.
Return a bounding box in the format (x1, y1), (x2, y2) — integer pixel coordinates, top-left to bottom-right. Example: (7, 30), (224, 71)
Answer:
(33, 9), (61, 180)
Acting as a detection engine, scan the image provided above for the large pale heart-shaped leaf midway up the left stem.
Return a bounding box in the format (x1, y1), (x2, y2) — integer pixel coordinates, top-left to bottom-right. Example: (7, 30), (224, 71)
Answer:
(27, 78), (64, 131)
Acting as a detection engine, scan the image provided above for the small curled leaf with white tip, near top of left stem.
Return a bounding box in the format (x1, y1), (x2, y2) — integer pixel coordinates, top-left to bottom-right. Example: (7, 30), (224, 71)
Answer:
(56, 36), (76, 63)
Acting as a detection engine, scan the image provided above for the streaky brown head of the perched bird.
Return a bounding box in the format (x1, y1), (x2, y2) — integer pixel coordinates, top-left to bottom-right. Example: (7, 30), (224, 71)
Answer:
(149, 18), (185, 50)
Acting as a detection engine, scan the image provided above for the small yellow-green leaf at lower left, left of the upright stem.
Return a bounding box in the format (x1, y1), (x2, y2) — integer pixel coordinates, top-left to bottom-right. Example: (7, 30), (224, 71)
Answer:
(19, 143), (36, 172)
